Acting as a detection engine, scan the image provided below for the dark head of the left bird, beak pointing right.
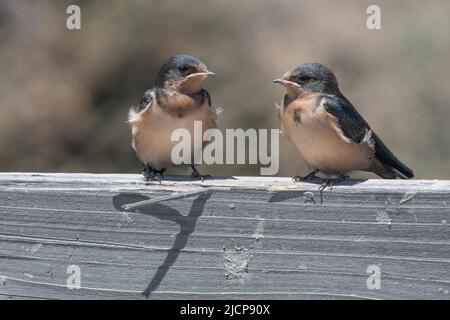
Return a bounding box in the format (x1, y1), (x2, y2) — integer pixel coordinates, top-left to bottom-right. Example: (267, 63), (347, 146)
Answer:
(155, 54), (214, 93)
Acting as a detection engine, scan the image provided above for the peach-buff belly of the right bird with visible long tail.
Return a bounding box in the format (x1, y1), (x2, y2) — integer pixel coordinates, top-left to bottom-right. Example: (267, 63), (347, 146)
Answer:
(284, 110), (373, 175)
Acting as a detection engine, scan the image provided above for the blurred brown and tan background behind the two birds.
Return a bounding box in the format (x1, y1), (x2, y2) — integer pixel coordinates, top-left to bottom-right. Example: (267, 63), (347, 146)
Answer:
(0, 0), (450, 179)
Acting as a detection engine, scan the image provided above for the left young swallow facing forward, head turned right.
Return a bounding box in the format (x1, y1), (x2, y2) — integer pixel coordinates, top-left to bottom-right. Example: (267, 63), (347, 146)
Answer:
(128, 55), (216, 181)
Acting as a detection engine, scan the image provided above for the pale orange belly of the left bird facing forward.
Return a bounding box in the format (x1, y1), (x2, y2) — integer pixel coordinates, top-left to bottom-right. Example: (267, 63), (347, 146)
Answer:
(131, 107), (215, 170)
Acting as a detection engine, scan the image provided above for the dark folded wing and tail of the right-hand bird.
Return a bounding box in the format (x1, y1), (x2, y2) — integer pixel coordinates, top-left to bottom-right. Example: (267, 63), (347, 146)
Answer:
(322, 96), (414, 178)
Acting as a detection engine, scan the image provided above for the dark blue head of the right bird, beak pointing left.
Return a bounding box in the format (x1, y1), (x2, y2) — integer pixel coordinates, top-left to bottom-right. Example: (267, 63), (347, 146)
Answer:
(274, 63), (339, 94)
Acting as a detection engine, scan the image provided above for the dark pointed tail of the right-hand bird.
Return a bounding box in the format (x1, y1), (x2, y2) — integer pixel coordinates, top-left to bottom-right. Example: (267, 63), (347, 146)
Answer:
(373, 134), (414, 179)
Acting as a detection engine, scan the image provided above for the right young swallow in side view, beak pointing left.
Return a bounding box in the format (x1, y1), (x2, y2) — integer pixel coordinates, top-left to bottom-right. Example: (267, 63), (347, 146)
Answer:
(274, 63), (414, 181)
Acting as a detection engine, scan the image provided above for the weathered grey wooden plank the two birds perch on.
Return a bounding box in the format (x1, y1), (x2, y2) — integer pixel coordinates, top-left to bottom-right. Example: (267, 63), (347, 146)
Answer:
(0, 173), (450, 299)
